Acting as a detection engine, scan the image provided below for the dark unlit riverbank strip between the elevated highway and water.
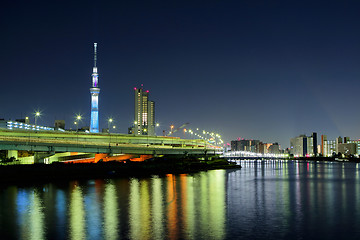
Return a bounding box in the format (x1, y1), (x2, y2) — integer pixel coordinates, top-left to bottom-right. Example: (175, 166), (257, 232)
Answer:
(0, 158), (241, 183)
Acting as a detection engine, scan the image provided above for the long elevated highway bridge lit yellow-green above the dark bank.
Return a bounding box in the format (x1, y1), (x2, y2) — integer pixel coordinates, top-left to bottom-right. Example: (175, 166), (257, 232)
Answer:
(0, 129), (222, 162)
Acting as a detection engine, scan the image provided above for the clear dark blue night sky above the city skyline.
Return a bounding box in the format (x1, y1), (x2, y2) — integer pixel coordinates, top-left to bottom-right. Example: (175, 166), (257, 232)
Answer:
(0, 0), (360, 147)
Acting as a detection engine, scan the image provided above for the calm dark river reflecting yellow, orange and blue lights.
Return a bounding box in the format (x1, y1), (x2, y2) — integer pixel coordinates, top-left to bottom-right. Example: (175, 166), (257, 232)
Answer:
(0, 160), (360, 240)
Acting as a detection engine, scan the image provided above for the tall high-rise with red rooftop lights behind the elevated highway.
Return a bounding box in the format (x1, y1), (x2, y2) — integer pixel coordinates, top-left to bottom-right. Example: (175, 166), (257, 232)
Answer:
(132, 85), (155, 135)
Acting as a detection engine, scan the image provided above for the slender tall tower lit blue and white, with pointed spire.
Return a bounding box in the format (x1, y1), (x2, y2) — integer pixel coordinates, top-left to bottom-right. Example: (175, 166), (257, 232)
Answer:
(90, 43), (100, 133)
